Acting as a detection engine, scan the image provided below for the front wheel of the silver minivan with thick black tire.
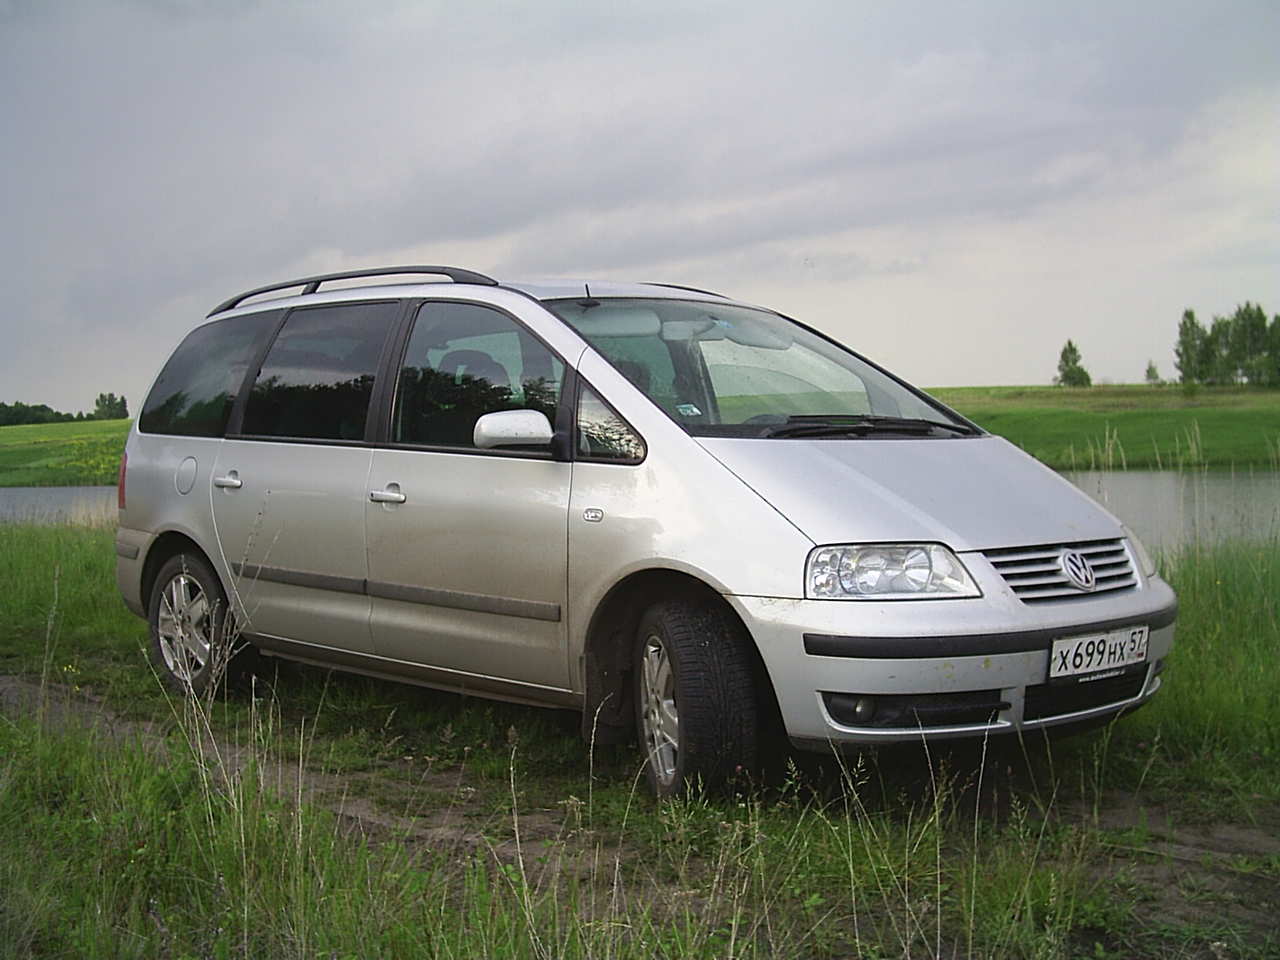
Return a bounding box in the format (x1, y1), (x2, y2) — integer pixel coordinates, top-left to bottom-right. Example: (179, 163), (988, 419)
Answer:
(634, 599), (762, 797)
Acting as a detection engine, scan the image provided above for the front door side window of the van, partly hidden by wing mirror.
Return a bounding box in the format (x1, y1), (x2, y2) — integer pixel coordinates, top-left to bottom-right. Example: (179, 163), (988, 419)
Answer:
(392, 303), (564, 447)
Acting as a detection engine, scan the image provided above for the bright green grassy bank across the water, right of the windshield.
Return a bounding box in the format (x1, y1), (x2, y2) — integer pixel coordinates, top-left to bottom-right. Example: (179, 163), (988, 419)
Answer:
(929, 385), (1280, 470)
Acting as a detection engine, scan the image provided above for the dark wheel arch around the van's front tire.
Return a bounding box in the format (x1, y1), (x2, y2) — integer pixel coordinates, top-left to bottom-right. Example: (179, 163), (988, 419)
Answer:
(582, 568), (781, 744)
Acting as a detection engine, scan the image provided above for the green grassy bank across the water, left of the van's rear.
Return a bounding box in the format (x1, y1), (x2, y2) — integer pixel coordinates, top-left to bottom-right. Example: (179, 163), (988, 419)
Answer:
(0, 420), (131, 486)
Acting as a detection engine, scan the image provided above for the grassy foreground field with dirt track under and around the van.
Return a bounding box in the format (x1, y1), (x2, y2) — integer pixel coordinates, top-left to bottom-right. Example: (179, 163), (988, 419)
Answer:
(0, 525), (1280, 959)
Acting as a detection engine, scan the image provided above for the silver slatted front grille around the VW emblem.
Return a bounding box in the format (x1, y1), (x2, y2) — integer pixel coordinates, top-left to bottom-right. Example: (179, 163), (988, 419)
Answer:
(983, 540), (1138, 603)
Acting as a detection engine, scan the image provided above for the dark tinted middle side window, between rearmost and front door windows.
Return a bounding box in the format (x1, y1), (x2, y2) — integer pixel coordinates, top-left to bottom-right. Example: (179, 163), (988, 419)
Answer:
(243, 301), (399, 440)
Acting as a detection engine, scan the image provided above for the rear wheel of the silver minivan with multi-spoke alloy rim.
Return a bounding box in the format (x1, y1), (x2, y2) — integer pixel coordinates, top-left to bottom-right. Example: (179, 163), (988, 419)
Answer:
(147, 553), (234, 695)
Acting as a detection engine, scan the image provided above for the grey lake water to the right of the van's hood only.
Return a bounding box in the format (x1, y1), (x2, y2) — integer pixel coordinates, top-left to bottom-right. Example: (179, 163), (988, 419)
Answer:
(1064, 470), (1280, 550)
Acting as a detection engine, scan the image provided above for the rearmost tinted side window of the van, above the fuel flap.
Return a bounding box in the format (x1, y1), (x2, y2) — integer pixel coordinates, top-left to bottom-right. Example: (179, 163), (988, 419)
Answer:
(138, 311), (280, 436)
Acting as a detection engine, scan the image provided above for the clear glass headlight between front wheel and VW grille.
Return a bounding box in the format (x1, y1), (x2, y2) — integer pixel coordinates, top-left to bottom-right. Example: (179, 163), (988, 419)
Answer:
(804, 543), (982, 600)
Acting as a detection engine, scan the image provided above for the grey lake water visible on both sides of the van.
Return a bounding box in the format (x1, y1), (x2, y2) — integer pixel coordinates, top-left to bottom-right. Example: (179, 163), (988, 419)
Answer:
(0, 470), (1280, 549)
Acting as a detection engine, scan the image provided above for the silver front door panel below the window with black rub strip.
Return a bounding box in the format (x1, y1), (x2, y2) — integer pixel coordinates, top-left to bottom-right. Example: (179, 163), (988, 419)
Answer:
(366, 449), (572, 689)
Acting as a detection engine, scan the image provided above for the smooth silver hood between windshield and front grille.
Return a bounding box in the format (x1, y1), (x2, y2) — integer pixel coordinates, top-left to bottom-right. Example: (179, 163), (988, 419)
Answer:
(695, 436), (1123, 552)
